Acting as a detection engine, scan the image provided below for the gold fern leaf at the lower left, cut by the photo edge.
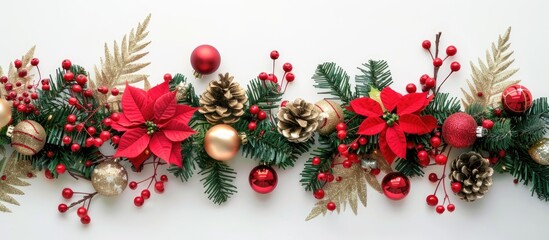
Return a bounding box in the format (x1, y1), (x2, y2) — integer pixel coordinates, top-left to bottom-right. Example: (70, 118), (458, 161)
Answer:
(0, 147), (35, 212)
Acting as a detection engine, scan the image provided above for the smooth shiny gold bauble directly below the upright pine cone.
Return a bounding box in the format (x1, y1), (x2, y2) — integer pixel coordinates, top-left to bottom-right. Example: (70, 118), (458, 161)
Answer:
(204, 124), (240, 161)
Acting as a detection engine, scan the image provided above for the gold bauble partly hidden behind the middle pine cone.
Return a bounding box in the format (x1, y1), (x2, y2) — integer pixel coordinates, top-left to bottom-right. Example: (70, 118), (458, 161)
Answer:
(315, 99), (344, 135)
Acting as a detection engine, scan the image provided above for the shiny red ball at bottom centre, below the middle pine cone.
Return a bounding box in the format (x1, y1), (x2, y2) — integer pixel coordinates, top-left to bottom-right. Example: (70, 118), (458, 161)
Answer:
(248, 165), (278, 194)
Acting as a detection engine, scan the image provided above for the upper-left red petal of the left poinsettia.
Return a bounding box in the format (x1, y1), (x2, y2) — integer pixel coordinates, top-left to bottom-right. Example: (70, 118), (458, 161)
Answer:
(122, 83), (147, 122)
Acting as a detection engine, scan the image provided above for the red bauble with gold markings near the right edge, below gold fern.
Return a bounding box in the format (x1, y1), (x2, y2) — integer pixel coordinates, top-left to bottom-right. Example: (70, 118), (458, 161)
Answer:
(501, 84), (532, 114)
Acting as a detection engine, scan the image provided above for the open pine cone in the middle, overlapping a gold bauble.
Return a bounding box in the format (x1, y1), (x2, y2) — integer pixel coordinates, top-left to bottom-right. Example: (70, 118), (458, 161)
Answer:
(276, 98), (320, 142)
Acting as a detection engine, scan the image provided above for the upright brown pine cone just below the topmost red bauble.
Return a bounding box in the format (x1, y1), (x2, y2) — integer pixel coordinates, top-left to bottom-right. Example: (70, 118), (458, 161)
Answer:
(198, 73), (248, 124)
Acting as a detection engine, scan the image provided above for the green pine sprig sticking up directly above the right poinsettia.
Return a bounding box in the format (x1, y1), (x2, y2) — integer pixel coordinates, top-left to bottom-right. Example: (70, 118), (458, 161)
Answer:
(355, 60), (393, 98)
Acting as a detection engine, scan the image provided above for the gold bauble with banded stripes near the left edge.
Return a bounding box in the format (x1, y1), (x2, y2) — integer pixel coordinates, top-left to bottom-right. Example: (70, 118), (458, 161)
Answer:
(7, 120), (46, 156)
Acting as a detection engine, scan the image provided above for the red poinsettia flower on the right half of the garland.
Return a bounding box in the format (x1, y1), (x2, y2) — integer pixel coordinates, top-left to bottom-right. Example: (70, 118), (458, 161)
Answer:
(351, 87), (437, 164)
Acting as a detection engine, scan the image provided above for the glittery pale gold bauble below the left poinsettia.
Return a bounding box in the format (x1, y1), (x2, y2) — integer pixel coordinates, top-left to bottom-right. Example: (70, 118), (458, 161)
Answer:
(91, 160), (128, 197)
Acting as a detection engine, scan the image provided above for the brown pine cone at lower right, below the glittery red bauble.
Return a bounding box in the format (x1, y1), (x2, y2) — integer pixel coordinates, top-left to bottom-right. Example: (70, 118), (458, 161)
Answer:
(449, 152), (494, 202)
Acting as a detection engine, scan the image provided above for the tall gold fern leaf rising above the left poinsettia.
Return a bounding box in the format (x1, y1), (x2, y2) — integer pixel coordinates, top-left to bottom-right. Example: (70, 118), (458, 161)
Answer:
(90, 14), (151, 107)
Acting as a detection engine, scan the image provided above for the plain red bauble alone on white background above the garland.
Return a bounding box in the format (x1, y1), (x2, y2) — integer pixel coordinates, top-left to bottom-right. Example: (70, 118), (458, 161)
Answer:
(191, 45), (221, 74)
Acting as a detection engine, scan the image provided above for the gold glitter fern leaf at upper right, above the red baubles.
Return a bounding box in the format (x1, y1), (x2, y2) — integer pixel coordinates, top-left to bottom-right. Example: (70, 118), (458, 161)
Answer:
(461, 27), (520, 108)
